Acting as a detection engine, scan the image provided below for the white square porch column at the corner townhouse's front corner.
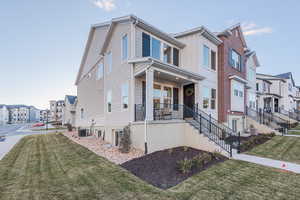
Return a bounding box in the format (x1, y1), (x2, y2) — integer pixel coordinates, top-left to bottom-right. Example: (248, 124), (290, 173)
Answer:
(145, 68), (154, 121)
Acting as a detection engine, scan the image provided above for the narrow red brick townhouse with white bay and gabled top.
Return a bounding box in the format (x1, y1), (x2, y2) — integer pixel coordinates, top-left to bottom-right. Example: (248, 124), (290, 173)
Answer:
(217, 24), (249, 132)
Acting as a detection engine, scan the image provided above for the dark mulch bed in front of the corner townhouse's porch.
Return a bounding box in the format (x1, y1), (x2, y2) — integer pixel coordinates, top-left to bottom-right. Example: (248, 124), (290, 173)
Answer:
(121, 147), (227, 189)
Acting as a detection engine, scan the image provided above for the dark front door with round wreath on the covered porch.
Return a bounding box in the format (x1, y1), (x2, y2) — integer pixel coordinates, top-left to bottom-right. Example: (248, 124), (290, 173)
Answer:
(183, 84), (195, 117)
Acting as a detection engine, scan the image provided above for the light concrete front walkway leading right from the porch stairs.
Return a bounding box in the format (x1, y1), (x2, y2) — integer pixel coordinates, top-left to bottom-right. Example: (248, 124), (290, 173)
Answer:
(232, 151), (300, 173)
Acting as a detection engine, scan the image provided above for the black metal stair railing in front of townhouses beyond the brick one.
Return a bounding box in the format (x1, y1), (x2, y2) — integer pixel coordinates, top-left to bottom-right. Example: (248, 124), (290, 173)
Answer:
(246, 107), (290, 133)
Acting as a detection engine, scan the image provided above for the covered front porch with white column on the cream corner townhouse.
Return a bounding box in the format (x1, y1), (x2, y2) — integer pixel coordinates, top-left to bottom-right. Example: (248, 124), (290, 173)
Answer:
(130, 58), (204, 121)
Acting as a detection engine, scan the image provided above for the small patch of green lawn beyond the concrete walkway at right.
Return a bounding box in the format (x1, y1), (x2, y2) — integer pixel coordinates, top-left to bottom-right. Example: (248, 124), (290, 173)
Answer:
(247, 136), (300, 164)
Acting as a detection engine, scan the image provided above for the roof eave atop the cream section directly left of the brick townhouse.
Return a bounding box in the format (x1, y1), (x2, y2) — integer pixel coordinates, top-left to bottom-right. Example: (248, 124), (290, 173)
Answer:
(173, 26), (223, 45)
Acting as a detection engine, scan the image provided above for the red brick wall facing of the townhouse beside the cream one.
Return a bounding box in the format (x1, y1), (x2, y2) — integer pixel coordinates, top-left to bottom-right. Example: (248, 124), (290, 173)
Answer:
(218, 27), (246, 122)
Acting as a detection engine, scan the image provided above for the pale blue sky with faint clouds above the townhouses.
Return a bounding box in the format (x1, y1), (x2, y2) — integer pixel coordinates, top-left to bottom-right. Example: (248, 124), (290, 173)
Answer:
(0, 0), (300, 109)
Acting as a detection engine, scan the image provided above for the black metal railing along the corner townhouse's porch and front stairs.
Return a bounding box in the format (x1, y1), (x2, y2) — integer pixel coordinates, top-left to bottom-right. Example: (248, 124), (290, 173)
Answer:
(135, 104), (239, 156)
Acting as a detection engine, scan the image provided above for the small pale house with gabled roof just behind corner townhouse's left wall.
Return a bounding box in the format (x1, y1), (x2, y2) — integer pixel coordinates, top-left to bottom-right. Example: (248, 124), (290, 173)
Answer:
(62, 95), (77, 126)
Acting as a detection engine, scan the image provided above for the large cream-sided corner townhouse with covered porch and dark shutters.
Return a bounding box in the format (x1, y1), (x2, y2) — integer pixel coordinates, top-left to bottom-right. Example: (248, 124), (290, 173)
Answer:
(76, 15), (232, 156)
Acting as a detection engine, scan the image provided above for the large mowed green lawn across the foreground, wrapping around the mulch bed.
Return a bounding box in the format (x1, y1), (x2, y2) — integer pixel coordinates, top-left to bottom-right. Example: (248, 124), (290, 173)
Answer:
(0, 134), (300, 200)
